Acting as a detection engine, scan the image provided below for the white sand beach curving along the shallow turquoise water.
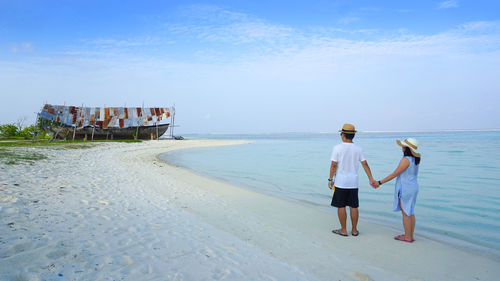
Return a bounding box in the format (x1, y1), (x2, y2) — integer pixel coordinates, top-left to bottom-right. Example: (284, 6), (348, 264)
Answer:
(0, 140), (500, 280)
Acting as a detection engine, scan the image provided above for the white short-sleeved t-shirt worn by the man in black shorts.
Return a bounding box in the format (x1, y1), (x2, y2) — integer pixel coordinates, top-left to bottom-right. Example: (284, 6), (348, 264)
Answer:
(331, 142), (366, 189)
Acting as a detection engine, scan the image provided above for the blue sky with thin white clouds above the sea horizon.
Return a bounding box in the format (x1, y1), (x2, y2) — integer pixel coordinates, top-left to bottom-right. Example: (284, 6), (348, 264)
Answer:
(0, 0), (500, 133)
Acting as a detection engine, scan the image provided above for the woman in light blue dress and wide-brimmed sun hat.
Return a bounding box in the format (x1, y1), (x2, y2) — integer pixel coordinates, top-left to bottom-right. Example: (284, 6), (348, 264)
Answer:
(373, 138), (420, 243)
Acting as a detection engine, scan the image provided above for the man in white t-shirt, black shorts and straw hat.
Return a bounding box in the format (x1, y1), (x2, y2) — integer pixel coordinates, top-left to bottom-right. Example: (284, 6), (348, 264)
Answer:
(328, 124), (374, 236)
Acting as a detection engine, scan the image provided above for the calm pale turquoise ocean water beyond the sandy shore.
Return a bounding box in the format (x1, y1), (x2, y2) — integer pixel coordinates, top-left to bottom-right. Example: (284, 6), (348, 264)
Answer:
(160, 131), (500, 255)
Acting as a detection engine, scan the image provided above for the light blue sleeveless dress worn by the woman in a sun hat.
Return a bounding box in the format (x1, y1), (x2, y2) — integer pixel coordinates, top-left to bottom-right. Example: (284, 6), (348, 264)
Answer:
(394, 156), (418, 216)
